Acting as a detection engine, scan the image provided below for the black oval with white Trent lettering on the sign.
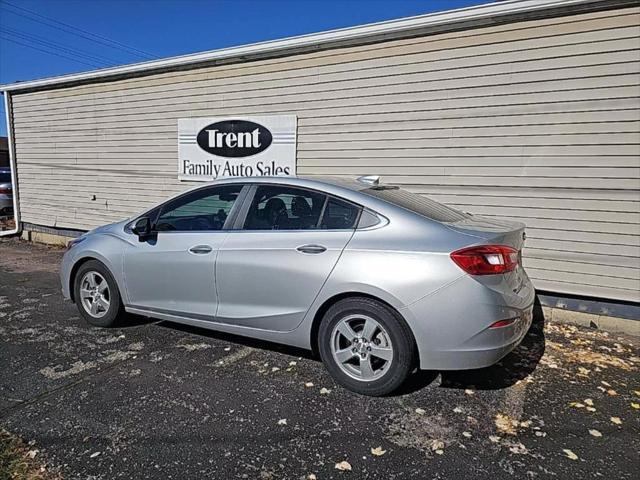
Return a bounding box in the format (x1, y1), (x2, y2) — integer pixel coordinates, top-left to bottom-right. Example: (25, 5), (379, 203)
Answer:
(197, 120), (273, 157)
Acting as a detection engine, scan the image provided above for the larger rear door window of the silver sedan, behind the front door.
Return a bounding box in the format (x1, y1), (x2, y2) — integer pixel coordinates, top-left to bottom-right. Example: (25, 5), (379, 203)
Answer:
(243, 185), (327, 230)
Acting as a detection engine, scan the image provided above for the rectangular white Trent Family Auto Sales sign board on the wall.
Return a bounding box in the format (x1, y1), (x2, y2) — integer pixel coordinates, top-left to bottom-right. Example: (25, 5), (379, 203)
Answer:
(178, 115), (297, 181)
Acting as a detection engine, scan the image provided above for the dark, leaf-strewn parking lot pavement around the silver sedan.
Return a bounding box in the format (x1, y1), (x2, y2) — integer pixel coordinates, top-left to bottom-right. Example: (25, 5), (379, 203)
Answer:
(0, 240), (640, 479)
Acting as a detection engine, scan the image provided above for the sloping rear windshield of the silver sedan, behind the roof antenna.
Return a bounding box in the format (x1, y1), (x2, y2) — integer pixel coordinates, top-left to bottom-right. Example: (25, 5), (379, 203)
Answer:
(362, 186), (470, 223)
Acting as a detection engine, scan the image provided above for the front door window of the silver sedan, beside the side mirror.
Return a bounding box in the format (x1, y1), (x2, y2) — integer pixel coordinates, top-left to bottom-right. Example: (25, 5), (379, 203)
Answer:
(155, 184), (243, 232)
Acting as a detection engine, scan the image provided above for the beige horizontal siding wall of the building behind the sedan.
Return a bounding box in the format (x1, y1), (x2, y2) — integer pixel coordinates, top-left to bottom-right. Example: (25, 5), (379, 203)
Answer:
(8, 8), (640, 301)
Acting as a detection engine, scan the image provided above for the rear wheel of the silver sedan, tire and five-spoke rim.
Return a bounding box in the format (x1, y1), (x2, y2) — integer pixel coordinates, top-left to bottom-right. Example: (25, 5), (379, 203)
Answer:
(318, 297), (417, 396)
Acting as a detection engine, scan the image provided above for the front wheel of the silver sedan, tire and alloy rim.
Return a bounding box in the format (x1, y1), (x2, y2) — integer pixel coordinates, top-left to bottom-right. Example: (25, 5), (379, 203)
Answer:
(73, 260), (124, 327)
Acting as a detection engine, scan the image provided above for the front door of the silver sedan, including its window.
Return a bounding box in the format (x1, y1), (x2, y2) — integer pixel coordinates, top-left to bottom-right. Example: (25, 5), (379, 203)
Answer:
(124, 184), (243, 320)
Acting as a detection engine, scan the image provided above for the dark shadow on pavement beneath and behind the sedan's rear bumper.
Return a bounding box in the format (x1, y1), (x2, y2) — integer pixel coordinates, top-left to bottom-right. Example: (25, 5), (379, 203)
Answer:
(396, 296), (545, 395)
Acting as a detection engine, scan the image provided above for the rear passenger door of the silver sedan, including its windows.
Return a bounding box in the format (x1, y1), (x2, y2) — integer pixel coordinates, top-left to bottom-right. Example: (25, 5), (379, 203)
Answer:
(216, 184), (360, 331)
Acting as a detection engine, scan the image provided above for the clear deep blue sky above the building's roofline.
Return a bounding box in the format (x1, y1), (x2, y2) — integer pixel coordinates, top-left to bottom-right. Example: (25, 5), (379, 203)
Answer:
(0, 0), (487, 135)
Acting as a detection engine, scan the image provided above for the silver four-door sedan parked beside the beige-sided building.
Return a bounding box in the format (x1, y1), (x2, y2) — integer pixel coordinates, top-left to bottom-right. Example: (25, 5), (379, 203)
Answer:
(61, 177), (534, 395)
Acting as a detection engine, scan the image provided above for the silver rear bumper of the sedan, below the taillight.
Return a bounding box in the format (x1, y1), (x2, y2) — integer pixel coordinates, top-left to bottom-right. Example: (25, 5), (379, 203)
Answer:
(400, 275), (535, 370)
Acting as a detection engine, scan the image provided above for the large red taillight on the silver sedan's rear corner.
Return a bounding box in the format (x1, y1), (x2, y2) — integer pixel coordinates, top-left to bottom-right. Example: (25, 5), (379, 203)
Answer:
(451, 245), (518, 275)
